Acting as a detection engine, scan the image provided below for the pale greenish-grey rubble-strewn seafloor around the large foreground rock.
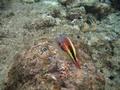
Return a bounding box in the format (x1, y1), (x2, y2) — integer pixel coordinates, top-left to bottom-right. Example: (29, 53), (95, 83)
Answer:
(0, 0), (120, 90)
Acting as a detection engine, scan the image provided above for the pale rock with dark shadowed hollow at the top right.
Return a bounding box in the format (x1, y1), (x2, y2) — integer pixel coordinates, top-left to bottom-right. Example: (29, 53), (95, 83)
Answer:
(58, 0), (113, 20)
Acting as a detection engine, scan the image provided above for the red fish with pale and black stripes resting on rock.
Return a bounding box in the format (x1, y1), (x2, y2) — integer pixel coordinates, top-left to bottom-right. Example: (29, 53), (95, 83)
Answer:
(57, 36), (80, 69)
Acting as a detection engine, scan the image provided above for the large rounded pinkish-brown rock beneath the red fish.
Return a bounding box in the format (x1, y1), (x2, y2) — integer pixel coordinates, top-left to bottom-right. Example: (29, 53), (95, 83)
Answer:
(5, 38), (105, 90)
